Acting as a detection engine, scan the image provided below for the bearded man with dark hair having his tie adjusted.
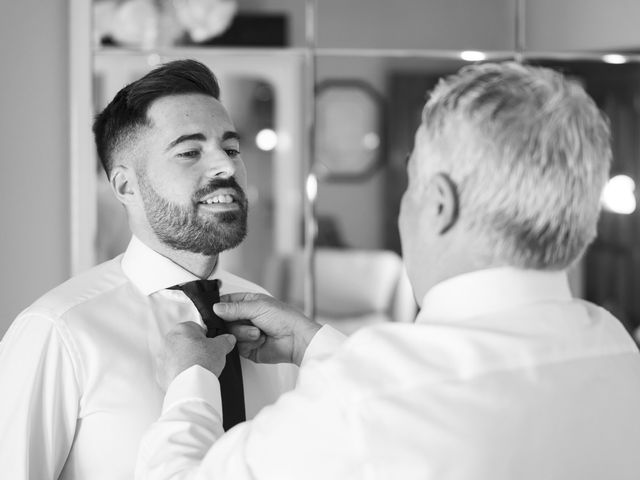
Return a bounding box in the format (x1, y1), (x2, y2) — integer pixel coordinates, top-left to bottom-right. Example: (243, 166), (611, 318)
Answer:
(0, 60), (297, 480)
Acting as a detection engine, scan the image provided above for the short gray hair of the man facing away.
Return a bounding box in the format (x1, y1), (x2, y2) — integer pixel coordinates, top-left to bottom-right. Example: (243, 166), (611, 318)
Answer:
(422, 63), (611, 270)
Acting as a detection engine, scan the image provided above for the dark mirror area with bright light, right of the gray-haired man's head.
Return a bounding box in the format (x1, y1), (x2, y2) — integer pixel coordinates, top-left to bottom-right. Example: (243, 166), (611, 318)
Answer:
(531, 59), (640, 338)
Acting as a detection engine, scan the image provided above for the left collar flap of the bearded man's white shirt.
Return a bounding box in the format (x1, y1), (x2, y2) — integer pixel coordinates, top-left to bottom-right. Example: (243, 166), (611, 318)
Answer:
(122, 235), (217, 295)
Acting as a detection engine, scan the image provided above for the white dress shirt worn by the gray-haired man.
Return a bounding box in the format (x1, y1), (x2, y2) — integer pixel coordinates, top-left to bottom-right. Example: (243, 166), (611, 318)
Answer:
(136, 269), (640, 480)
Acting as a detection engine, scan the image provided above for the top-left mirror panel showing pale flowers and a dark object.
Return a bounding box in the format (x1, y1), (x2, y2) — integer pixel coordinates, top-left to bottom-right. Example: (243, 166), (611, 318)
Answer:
(92, 0), (305, 50)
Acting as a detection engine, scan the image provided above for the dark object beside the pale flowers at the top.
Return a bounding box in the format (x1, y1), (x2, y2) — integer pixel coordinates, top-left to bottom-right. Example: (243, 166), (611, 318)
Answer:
(184, 13), (289, 47)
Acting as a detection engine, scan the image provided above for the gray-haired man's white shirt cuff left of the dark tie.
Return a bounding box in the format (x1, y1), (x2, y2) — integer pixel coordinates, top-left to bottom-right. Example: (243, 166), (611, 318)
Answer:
(162, 365), (222, 417)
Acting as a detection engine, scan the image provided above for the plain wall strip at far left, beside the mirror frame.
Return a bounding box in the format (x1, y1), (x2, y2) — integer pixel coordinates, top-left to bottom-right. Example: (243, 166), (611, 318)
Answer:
(0, 0), (69, 335)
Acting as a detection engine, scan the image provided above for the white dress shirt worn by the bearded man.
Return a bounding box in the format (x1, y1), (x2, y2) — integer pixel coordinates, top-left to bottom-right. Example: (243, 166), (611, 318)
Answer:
(0, 238), (297, 480)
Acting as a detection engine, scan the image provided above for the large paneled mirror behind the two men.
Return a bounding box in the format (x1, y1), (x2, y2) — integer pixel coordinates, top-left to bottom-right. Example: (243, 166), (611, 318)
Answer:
(71, 0), (640, 338)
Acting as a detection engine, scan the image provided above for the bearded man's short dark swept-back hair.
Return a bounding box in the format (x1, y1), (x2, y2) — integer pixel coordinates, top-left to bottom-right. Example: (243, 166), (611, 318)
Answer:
(93, 60), (220, 177)
